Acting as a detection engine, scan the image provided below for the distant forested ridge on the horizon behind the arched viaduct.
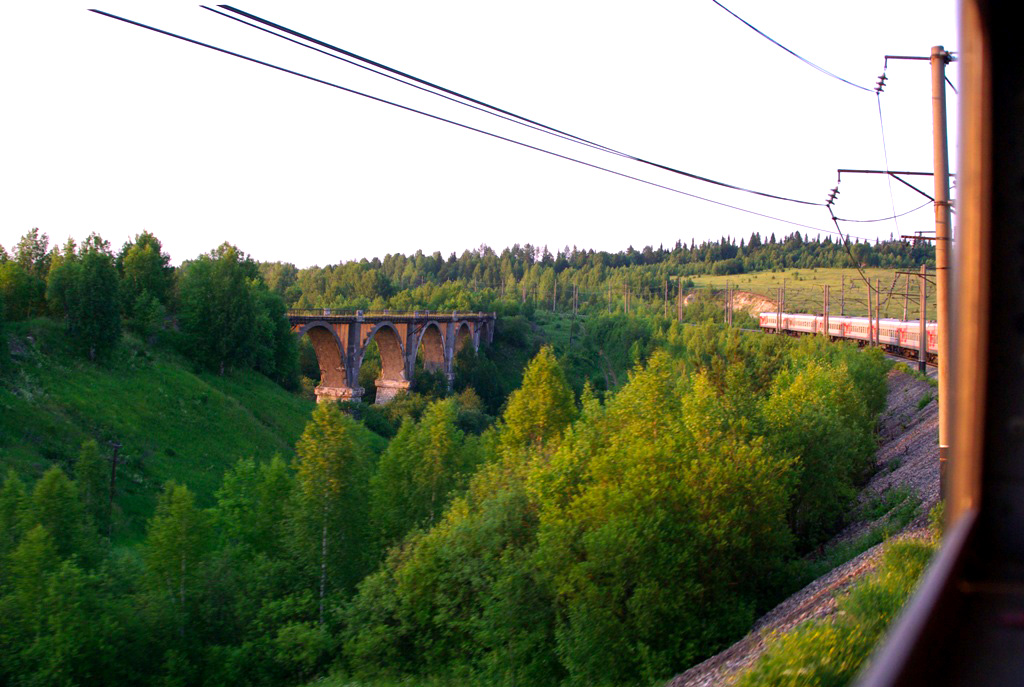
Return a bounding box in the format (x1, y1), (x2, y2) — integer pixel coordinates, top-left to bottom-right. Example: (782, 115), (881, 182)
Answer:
(260, 231), (934, 310)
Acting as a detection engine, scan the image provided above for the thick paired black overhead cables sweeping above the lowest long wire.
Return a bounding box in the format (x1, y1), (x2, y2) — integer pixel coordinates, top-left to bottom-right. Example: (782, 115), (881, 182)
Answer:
(214, 5), (822, 206)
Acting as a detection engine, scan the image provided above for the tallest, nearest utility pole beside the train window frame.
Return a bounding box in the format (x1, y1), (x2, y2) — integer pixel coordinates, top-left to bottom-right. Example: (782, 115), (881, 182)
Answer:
(922, 45), (952, 495)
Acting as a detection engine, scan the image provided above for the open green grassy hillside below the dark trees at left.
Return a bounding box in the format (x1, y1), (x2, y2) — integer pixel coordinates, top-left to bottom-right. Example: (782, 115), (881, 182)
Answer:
(0, 319), (313, 542)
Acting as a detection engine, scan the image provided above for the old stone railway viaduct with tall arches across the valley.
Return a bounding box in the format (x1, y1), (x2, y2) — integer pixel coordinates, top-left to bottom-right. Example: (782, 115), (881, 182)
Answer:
(288, 308), (496, 403)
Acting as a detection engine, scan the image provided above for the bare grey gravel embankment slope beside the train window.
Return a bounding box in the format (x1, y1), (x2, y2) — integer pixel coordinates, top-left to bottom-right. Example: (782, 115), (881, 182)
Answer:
(667, 366), (939, 687)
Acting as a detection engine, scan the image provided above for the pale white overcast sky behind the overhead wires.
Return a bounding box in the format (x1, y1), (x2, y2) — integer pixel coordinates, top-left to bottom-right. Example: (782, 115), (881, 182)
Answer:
(0, 0), (958, 267)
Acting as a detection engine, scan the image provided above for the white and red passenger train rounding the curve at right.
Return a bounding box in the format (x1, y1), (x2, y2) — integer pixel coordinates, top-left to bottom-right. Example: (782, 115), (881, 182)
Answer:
(759, 312), (939, 364)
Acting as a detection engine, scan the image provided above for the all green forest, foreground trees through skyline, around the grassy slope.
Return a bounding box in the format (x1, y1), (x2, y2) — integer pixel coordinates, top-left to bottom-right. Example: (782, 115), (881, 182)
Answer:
(0, 230), (897, 685)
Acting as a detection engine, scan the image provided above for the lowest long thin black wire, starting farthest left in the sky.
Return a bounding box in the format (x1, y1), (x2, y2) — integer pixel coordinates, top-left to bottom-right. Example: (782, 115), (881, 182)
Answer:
(89, 9), (857, 238)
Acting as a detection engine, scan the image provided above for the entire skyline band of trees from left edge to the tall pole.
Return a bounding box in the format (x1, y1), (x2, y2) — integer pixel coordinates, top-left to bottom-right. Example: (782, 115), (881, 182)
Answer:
(0, 229), (934, 389)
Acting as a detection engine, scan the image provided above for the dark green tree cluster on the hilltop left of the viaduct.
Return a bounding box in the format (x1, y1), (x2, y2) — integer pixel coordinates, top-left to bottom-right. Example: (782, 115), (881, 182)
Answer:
(0, 229), (298, 388)
